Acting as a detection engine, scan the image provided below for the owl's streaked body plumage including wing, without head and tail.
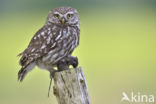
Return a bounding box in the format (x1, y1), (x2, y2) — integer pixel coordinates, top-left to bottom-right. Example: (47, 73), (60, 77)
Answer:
(19, 26), (79, 68)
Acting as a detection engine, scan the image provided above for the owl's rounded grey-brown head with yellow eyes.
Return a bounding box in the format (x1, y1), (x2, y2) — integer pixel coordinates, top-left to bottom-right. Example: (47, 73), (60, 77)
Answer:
(47, 7), (79, 26)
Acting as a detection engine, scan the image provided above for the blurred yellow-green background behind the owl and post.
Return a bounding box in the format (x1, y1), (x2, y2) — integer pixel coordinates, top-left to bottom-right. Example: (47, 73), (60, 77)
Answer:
(0, 0), (156, 104)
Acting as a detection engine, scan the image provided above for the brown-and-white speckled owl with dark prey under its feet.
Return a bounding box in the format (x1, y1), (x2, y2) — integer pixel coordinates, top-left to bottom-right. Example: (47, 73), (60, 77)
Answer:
(18, 7), (80, 82)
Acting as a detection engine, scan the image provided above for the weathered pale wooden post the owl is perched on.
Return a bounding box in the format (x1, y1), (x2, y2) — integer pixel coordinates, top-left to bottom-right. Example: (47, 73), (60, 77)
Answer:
(53, 67), (90, 104)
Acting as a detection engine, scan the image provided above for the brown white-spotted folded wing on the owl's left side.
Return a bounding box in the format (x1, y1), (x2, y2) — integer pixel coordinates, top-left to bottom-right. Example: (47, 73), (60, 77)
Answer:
(19, 27), (56, 67)
